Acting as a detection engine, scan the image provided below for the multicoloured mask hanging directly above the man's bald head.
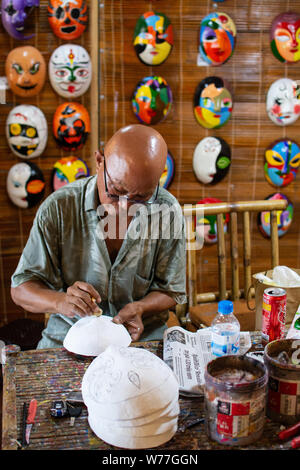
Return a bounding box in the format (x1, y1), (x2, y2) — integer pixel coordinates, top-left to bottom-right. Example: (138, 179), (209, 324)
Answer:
(132, 76), (173, 125)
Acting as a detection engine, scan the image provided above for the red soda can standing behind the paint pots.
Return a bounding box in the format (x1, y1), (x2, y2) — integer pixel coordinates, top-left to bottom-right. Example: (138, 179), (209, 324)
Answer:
(262, 287), (286, 344)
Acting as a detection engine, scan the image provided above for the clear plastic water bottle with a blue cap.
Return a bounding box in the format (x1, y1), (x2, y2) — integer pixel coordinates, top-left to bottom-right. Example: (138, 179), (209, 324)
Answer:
(211, 300), (240, 357)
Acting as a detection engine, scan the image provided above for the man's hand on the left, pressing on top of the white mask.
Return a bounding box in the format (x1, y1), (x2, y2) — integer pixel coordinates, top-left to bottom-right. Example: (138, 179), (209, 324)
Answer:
(56, 281), (101, 317)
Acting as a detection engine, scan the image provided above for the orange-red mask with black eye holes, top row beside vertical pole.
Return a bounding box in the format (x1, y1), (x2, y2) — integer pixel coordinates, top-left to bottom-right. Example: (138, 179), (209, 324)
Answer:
(48, 0), (88, 41)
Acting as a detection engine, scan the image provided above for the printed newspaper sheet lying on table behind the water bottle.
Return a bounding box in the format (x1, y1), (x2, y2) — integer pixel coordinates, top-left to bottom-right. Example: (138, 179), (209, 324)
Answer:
(163, 326), (251, 397)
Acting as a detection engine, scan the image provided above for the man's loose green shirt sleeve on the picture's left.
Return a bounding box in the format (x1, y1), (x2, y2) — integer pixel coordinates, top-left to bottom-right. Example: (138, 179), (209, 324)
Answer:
(11, 206), (63, 290)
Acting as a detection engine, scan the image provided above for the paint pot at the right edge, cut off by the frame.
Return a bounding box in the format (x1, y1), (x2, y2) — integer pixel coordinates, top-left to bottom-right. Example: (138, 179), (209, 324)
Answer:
(264, 339), (300, 424)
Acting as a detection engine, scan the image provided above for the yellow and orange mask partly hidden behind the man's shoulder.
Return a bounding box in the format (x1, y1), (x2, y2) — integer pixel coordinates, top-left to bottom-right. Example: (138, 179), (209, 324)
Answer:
(52, 157), (89, 191)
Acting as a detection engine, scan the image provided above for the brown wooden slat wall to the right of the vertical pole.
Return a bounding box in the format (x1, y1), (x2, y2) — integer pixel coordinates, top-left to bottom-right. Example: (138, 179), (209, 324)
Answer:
(100, 0), (300, 300)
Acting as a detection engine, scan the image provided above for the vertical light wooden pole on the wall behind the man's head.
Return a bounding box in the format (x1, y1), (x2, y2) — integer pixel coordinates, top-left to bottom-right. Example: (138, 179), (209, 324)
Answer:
(90, 1), (100, 174)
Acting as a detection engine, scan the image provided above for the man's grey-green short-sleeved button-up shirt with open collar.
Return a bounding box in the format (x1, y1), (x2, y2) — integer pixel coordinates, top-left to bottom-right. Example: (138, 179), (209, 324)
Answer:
(12, 176), (186, 346)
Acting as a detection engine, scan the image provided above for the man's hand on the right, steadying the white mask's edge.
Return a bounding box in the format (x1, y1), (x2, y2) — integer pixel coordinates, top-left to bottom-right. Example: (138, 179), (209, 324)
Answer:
(113, 302), (144, 341)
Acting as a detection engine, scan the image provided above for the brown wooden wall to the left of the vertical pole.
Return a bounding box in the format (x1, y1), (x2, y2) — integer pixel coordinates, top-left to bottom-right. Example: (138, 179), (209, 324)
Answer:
(0, 0), (92, 324)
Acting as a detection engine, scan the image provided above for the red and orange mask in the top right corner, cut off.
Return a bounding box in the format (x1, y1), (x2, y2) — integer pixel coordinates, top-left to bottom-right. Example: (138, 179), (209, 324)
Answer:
(270, 12), (300, 62)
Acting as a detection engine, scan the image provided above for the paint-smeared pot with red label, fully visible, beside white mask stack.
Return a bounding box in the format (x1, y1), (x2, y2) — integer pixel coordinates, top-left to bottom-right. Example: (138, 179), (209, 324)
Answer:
(204, 356), (268, 446)
